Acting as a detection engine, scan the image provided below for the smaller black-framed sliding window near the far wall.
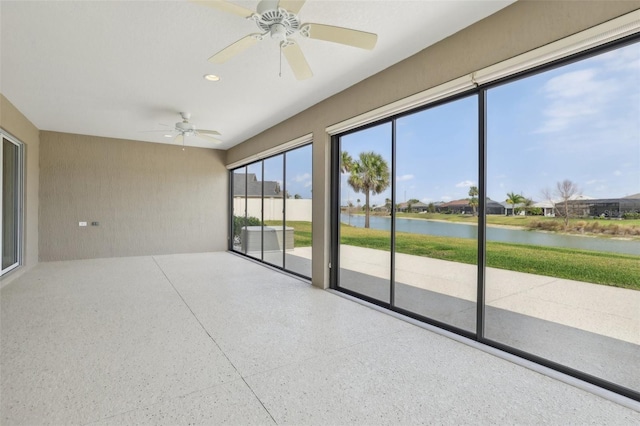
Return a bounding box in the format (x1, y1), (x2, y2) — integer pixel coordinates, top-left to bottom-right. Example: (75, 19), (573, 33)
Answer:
(229, 141), (312, 278)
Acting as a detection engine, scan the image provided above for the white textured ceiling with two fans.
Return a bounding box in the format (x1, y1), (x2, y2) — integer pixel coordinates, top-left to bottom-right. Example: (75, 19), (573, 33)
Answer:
(0, 0), (513, 149)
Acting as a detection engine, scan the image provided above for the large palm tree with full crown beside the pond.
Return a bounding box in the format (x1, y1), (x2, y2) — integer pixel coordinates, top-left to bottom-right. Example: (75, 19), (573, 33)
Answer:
(347, 151), (389, 228)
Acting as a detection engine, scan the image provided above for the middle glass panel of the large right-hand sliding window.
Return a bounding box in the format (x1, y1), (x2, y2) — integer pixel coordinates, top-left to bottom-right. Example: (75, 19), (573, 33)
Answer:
(395, 96), (478, 332)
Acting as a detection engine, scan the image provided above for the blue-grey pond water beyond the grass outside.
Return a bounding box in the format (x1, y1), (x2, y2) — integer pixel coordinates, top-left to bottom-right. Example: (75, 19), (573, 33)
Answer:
(340, 214), (640, 256)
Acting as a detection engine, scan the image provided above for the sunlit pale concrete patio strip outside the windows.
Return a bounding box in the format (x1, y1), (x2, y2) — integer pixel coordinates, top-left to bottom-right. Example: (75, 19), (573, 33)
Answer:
(308, 245), (640, 345)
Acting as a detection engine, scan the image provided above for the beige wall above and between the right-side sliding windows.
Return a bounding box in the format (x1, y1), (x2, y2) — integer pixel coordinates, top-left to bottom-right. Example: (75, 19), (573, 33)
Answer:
(227, 0), (639, 287)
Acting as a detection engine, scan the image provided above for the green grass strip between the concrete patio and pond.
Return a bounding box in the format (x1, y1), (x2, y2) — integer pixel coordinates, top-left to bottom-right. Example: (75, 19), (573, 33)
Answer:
(267, 222), (640, 290)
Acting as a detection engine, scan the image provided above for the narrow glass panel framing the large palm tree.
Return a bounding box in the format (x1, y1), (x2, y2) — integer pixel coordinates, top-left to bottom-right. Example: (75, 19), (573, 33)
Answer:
(339, 123), (391, 303)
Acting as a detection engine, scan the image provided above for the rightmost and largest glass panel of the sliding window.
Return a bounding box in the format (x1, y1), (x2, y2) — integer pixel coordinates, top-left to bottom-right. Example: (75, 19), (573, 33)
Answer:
(485, 43), (640, 391)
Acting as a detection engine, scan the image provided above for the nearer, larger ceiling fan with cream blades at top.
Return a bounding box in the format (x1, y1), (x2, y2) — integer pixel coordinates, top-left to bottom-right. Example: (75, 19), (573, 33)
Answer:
(190, 0), (378, 80)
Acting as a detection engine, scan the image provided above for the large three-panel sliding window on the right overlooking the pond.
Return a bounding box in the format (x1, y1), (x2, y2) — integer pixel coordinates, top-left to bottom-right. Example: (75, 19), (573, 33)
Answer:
(331, 37), (640, 400)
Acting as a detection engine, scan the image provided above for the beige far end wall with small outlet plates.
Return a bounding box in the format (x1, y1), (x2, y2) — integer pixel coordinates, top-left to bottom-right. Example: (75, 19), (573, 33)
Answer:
(40, 131), (228, 261)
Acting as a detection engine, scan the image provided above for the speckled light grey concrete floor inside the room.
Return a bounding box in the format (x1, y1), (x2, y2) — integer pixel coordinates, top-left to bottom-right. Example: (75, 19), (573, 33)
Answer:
(0, 253), (640, 425)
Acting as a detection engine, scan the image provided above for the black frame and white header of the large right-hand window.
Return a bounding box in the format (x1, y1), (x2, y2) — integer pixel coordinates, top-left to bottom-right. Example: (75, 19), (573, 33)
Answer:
(327, 34), (640, 401)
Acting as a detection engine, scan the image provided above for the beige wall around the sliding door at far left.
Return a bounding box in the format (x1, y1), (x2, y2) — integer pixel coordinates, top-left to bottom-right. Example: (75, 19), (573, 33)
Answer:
(0, 93), (40, 285)
